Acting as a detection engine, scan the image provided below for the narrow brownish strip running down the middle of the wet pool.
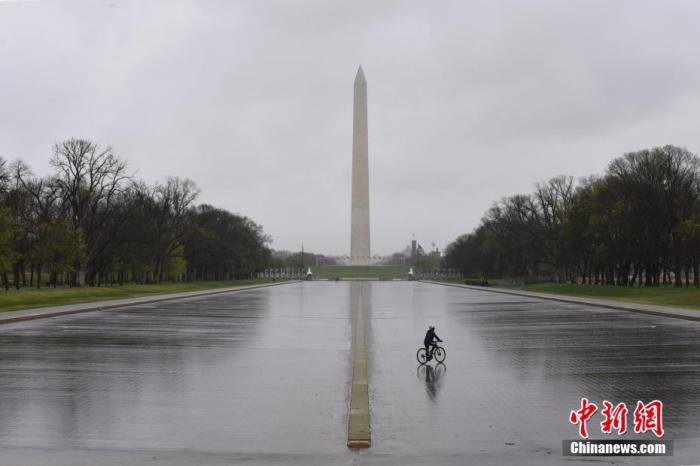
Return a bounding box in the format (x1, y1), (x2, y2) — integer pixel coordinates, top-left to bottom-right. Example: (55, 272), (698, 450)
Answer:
(348, 286), (372, 449)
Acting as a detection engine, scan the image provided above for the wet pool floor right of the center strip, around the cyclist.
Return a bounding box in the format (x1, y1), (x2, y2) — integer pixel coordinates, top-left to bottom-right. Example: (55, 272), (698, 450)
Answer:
(369, 283), (700, 465)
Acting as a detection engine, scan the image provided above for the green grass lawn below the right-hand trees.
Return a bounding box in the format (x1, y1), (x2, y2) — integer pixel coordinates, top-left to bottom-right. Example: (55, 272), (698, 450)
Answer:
(504, 283), (700, 309)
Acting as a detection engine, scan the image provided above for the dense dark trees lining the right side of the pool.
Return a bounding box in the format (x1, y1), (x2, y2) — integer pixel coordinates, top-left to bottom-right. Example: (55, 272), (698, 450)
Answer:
(444, 145), (700, 287)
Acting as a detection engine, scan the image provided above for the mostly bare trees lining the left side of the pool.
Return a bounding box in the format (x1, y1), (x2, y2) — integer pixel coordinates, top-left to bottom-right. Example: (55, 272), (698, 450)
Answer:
(0, 139), (271, 289)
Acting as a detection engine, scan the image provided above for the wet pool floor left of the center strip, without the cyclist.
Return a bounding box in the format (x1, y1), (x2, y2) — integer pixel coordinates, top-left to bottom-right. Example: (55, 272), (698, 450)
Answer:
(0, 283), (350, 465)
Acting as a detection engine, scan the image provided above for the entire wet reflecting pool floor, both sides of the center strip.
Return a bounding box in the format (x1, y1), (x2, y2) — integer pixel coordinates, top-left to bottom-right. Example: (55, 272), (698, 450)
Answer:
(0, 282), (700, 465)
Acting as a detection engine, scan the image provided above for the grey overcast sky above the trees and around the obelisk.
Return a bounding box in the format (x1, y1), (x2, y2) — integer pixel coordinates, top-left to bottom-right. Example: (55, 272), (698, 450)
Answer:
(0, 0), (700, 254)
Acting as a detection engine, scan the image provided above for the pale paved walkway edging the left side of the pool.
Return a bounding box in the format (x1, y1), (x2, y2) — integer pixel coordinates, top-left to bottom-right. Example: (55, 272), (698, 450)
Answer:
(0, 280), (299, 325)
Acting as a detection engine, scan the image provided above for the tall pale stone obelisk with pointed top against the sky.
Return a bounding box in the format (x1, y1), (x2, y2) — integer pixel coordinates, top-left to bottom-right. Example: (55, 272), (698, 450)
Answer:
(350, 66), (370, 265)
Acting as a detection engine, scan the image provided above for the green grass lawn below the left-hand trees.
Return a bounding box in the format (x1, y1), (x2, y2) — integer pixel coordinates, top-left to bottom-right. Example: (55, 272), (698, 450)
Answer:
(0, 279), (270, 312)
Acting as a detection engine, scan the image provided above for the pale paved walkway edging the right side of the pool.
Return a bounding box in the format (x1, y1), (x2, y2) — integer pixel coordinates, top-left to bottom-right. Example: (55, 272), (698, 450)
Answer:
(420, 280), (700, 321)
